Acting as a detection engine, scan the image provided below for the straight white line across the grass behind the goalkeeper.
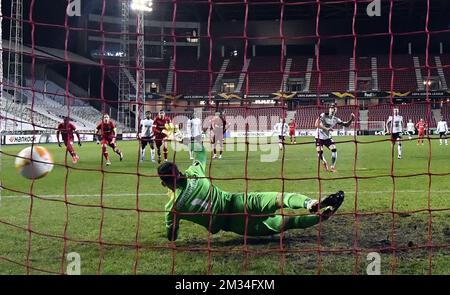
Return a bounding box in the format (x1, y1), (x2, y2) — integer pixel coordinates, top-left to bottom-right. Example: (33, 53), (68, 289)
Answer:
(0, 190), (450, 199)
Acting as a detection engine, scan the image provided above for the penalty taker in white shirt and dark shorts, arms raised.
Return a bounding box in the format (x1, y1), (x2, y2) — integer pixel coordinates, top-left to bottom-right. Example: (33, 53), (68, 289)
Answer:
(315, 103), (355, 172)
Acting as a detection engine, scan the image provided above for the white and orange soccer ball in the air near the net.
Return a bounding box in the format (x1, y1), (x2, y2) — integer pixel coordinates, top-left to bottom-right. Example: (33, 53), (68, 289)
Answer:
(15, 146), (53, 179)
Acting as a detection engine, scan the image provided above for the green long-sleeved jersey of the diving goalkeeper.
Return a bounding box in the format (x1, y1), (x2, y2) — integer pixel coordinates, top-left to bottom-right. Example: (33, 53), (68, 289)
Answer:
(166, 148), (236, 240)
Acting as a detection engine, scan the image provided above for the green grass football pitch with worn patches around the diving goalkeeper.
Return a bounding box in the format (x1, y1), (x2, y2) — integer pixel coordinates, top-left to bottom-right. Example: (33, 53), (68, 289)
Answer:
(0, 137), (450, 274)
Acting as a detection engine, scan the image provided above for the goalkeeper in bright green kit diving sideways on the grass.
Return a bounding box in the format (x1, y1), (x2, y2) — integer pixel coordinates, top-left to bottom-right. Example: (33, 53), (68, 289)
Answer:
(158, 145), (344, 241)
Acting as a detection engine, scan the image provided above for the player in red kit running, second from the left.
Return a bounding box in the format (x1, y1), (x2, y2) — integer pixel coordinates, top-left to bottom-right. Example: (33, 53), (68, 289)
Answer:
(96, 114), (123, 166)
